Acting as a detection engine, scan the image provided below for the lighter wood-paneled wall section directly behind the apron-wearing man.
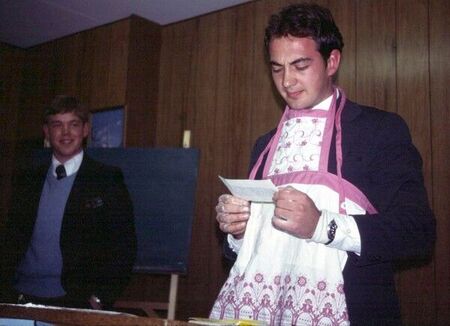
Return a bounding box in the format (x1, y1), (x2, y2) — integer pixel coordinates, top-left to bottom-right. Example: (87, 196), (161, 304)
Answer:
(156, 0), (450, 325)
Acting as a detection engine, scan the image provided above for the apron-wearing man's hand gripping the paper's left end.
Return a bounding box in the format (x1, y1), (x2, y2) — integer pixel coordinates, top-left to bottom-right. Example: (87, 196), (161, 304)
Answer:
(216, 195), (250, 239)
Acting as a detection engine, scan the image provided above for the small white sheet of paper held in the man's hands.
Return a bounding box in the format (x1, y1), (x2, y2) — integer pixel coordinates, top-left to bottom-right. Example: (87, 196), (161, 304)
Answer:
(219, 175), (277, 203)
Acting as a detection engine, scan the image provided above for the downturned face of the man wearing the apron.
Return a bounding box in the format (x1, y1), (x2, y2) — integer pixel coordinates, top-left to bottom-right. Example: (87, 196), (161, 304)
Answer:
(269, 35), (340, 109)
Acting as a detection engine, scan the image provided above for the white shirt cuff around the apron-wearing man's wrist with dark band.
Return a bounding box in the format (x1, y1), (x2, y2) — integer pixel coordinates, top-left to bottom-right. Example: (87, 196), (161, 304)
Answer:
(309, 210), (361, 255)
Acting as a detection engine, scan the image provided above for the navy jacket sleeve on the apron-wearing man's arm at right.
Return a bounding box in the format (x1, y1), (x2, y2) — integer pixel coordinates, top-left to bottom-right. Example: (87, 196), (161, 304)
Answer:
(352, 114), (435, 265)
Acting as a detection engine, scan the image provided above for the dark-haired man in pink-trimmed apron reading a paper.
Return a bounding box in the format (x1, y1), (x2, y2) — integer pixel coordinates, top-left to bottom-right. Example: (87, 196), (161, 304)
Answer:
(211, 3), (435, 326)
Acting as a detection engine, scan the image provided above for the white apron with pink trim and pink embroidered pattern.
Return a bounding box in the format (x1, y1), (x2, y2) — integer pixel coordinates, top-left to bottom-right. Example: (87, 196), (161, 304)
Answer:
(210, 90), (376, 326)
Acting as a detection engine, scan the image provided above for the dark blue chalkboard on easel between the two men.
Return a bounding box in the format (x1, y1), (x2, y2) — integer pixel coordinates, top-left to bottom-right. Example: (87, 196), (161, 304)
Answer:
(33, 148), (199, 274)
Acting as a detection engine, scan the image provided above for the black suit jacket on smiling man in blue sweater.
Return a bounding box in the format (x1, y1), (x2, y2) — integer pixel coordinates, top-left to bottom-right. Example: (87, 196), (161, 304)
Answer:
(0, 154), (136, 305)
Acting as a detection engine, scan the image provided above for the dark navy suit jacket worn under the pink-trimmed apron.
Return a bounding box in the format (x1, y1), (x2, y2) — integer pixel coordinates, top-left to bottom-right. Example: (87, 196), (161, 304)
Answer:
(226, 101), (435, 326)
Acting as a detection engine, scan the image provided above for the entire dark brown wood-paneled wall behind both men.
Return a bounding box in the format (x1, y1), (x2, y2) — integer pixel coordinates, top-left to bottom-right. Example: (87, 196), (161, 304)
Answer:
(0, 0), (450, 326)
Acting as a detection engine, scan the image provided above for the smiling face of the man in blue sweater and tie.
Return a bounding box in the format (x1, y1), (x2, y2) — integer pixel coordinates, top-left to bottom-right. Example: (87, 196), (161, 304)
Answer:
(43, 112), (89, 163)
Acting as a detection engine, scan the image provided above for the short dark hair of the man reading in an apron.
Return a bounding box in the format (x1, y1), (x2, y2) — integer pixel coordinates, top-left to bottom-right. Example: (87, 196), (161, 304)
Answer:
(264, 3), (344, 62)
